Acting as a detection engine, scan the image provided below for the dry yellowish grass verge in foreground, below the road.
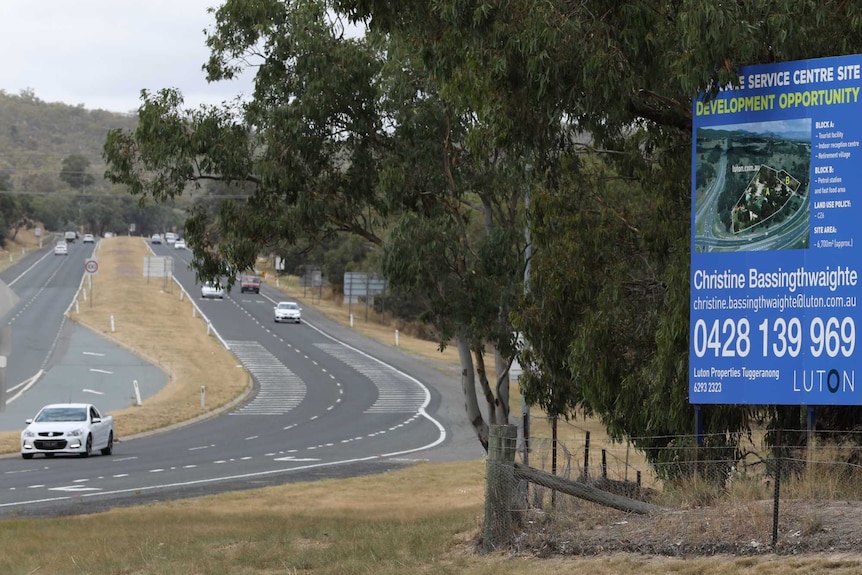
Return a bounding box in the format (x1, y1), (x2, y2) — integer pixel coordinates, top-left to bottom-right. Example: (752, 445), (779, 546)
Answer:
(5, 461), (862, 575)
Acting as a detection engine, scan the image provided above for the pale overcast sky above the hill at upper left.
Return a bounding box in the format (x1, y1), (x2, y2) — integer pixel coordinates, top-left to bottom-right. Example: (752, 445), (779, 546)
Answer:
(0, 0), (252, 112)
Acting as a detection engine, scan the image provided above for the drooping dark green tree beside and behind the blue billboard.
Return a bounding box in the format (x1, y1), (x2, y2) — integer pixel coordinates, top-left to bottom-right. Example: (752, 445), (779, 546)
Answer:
(338, 0), (862, 462)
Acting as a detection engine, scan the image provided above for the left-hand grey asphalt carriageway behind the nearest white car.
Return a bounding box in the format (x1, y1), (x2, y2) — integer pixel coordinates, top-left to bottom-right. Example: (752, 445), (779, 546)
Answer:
(0, 238), (167, 431)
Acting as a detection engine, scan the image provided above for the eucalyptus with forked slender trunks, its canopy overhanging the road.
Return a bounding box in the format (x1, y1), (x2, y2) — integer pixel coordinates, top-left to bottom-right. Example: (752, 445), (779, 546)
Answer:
(105, 0), (524, 445)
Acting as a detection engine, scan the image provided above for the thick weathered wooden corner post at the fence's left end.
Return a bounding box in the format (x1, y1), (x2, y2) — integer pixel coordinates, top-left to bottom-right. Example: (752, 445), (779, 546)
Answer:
(482, 425), (518, 552)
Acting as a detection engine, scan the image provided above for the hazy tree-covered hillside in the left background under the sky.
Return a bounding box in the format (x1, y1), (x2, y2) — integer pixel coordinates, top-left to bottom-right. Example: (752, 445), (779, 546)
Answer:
(0, 90), (188, 241)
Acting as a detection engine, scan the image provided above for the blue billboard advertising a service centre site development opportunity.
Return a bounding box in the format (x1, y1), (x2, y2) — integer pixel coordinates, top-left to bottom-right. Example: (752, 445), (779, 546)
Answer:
(689, 55), (862, 405)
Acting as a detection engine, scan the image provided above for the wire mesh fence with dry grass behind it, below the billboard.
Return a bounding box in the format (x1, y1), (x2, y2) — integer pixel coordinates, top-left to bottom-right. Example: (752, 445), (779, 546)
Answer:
(483, 426), (862, 554)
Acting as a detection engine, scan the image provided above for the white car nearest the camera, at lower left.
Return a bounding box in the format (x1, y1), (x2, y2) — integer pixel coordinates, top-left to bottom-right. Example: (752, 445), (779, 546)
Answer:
(21, 403), (114, 459)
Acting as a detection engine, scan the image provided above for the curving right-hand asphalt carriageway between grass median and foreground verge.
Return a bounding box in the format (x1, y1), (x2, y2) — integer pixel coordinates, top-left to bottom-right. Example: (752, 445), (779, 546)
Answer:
(0, 241), (483, 515)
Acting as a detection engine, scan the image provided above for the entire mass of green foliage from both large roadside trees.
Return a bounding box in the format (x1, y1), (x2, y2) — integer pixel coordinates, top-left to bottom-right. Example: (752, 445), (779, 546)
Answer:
(105, 0), (862, 460)
